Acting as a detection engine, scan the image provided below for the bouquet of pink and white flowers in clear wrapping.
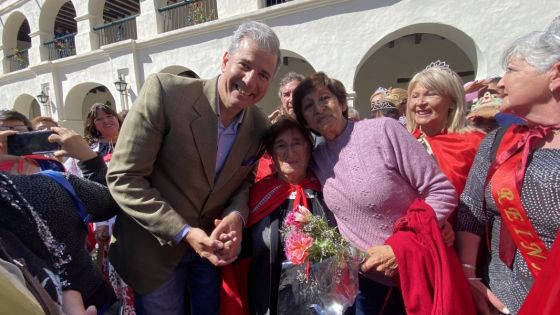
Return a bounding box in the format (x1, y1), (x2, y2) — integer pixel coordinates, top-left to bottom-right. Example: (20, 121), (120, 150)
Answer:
(279, 206), (359, 315)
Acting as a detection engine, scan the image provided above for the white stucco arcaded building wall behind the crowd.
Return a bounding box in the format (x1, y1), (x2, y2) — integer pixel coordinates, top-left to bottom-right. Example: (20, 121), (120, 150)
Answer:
(0, 0), (560, 125)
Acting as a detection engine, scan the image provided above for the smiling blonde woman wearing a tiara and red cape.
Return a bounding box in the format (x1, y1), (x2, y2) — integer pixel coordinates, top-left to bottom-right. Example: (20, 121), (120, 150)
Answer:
(406, 60), (484, 224)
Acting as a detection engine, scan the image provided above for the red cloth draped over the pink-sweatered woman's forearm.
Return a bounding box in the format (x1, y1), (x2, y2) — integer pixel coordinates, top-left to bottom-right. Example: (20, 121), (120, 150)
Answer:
(385, 199), (476, 315)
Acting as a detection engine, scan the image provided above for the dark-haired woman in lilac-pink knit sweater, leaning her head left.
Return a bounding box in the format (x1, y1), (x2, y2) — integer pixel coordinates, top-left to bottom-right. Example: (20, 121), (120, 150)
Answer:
(294, 72), (457, 314)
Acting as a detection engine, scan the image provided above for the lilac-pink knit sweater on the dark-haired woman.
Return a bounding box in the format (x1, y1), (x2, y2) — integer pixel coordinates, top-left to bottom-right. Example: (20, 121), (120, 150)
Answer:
(312, 118), (457, 250)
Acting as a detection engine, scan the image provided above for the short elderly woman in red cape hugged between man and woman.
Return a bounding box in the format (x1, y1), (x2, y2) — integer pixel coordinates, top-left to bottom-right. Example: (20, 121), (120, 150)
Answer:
(220, 116), (334, 315)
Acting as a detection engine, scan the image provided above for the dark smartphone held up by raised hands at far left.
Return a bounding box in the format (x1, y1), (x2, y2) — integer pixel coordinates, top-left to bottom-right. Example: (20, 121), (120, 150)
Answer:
(8, 130), (60, 156)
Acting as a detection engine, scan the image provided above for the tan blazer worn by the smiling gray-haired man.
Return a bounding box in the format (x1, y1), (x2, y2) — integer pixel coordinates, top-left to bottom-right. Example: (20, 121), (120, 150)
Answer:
(107, 74), (269, 294)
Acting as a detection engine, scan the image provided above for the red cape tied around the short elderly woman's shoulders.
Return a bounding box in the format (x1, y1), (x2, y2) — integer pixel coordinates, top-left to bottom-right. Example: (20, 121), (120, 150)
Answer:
(220, 173), (321, 315)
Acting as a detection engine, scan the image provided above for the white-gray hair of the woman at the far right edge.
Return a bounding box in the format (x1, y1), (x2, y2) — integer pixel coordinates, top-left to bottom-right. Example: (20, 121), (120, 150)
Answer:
(502, 16), (560, 72)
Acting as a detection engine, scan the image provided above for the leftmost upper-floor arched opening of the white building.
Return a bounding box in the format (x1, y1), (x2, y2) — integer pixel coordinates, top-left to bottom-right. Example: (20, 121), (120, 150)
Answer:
(2, 12), (31, 72)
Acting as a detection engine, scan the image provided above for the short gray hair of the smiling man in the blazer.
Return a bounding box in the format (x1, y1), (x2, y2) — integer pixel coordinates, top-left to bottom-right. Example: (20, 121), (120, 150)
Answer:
(228, 21), (282, 70)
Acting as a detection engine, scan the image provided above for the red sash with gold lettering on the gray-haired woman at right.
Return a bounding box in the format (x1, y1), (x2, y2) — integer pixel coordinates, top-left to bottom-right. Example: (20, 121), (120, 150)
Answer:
(485, 126), (550, 278)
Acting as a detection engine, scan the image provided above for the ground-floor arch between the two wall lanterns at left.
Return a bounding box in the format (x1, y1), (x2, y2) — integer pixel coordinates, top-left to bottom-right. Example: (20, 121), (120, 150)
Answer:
(64, 82), (116, 133)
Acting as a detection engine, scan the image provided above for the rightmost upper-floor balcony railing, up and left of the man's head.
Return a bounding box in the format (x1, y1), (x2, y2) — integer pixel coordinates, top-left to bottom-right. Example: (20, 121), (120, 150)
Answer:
(158, 0), (218, 32)
